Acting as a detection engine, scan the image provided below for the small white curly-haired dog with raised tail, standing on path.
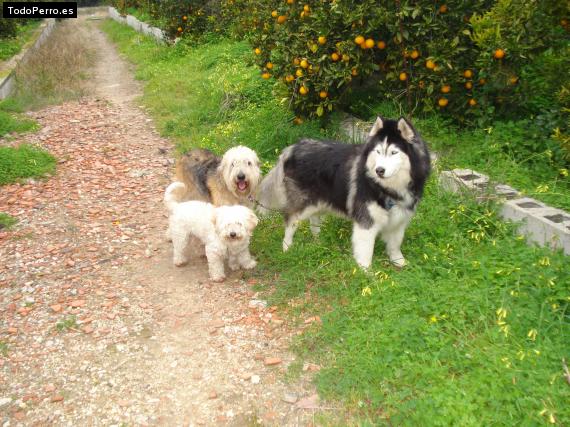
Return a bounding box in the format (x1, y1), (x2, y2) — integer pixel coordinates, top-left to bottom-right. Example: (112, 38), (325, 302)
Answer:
(164, 182), (258, 282)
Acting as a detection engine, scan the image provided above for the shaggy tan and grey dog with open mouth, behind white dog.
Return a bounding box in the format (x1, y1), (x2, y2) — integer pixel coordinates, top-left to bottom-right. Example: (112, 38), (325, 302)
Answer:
(176, 146), (261, 206)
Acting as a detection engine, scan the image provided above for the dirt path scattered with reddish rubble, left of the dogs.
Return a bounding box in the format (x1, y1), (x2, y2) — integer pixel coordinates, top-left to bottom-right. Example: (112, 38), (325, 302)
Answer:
(0, 10), (315, 426)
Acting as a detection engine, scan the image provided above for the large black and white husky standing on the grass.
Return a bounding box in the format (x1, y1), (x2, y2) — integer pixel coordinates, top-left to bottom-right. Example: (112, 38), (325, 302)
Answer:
(258, 117), (430, 268)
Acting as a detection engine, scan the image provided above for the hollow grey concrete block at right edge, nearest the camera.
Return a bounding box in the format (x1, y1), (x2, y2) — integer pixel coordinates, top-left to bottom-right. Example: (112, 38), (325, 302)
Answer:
(501, 197), (570, 255)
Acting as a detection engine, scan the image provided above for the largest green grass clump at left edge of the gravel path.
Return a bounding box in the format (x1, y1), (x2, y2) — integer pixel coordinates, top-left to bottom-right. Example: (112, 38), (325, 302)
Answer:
(0, 144), (56, 185)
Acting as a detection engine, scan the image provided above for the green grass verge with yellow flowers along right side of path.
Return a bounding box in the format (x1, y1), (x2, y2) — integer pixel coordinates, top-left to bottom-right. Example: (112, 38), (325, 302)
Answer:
(103, 22), (570, 426)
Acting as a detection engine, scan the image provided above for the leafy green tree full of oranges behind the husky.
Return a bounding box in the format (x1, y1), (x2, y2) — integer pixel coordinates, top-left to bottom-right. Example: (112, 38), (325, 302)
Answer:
(241, 0), (568, 121)
